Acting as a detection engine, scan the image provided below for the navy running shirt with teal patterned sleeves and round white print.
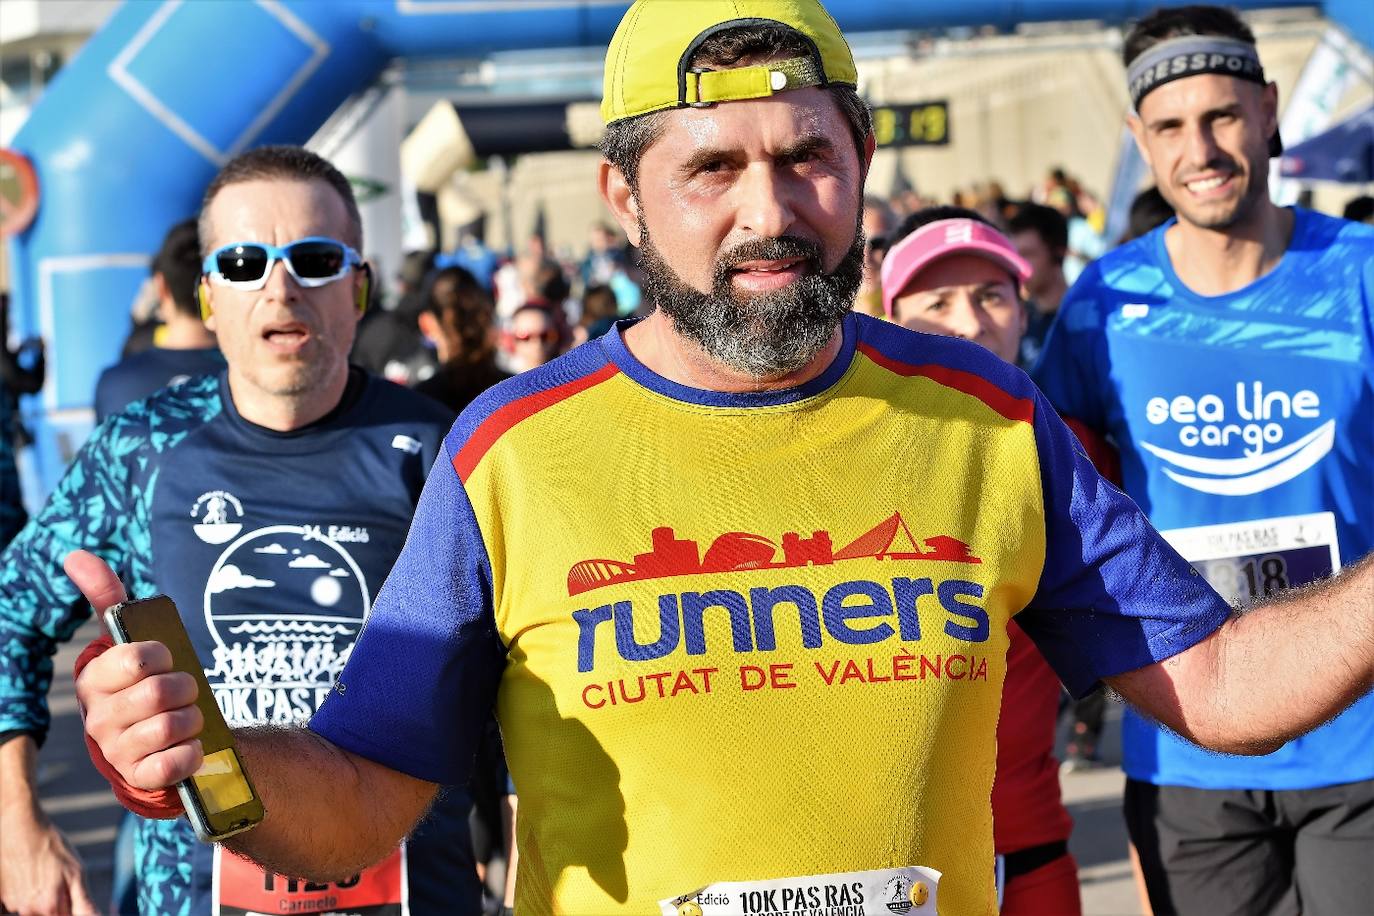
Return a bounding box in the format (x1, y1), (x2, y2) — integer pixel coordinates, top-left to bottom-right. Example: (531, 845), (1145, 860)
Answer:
(0, 369), (480, 913)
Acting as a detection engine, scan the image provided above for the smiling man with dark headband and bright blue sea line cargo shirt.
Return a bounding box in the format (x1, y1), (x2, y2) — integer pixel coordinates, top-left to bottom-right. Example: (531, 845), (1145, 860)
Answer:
(1037, 7), (1374, 916)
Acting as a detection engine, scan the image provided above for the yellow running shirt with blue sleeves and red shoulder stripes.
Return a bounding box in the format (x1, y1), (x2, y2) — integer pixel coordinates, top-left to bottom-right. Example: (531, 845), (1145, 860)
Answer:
(311, 314), (1228, 913)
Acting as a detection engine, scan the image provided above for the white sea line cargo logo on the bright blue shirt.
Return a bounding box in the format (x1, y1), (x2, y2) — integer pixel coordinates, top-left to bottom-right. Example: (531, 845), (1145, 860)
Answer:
(1140, 382), (1336, 496)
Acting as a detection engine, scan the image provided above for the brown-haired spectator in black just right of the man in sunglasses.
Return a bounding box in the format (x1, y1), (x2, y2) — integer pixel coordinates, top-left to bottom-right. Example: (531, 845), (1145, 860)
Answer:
(414, 268), (510, 413)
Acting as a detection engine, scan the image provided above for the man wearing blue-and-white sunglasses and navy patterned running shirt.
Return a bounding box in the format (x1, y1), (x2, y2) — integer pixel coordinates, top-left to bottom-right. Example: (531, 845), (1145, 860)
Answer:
(0, 147), (480, 916)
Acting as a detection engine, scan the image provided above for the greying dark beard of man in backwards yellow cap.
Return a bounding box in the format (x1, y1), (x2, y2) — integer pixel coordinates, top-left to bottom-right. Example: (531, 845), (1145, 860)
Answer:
(640, 221), (864, 379)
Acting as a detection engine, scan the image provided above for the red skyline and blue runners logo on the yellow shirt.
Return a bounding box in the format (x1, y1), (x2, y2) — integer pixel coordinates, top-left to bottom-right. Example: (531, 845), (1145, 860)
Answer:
(567, 512), (991, 683)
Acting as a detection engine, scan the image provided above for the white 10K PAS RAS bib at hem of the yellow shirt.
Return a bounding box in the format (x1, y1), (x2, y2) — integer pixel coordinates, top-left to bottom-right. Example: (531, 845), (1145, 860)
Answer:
(658, 865), (940, 916)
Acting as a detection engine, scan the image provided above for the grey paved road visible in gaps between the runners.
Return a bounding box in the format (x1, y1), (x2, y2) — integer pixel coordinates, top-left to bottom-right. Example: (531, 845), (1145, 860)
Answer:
(40, 621), (1140, 916)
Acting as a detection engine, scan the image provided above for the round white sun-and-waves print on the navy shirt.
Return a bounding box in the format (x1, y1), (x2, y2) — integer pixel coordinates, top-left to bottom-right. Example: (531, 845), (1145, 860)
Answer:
(203, 525), (371, 725)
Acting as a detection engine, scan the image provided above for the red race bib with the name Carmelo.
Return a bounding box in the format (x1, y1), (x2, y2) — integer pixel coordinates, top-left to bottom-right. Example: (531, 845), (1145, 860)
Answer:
(213, 845), (411, 916)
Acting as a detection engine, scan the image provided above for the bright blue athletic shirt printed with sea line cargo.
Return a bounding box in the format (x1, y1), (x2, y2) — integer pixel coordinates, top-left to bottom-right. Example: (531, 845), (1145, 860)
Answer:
(1036, 209), (1374, 788)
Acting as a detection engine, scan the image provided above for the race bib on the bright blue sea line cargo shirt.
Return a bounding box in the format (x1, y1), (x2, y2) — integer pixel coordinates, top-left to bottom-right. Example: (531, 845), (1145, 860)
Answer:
(1160, 512), (1341, 606)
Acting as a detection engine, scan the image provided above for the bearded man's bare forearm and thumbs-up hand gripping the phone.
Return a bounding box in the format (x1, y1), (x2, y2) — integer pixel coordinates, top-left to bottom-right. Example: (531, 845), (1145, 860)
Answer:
(66, 552), (438, 880)
